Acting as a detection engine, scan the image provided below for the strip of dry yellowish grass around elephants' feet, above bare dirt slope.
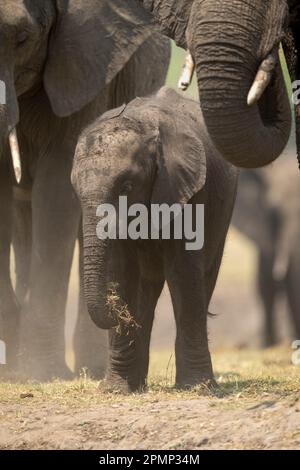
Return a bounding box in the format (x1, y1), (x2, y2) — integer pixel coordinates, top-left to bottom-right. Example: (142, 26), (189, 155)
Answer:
(0, 346), (300, 407)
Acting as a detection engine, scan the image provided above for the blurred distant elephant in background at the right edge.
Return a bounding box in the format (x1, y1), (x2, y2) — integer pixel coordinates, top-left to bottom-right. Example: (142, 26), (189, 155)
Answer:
(232, 163), (300, 346)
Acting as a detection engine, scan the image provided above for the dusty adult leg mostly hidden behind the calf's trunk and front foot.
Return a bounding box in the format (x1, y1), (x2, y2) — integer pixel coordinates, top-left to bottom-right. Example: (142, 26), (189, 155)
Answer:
(74, 226), (108, 379)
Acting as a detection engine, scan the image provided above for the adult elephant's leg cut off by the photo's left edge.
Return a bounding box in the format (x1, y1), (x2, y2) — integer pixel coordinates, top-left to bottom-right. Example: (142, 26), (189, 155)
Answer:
(0, 155), (20, 375)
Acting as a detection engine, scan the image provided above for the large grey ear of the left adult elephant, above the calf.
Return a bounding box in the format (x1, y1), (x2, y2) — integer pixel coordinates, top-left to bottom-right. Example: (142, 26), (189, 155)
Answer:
(44, 0), (153, 117)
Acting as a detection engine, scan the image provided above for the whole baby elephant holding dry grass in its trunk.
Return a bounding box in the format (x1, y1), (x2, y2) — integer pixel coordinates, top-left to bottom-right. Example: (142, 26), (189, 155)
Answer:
(72, 88), (237, 392)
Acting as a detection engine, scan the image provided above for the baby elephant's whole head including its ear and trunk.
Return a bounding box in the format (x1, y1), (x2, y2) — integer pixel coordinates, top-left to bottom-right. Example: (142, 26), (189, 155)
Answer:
(72, 89), (206, 329)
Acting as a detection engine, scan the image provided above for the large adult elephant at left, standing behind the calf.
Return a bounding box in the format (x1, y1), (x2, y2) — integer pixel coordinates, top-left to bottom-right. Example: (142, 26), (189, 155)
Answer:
(0, 0), (170, 380)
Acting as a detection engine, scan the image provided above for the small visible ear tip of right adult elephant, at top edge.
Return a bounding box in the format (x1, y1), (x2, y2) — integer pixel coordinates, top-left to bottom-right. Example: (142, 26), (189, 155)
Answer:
(139, 0), (194, 49)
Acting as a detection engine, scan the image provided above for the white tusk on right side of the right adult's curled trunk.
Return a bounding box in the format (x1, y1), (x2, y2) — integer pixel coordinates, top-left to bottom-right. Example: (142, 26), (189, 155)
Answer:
(247, 48), (278, 106)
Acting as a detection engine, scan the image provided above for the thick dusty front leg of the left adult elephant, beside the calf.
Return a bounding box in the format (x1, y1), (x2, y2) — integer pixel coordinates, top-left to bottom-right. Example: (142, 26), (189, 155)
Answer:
(21, 143), (80, 380)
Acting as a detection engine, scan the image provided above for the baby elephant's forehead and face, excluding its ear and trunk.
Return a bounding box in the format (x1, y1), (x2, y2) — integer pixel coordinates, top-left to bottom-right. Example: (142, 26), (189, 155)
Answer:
(72, 111), (156, 210)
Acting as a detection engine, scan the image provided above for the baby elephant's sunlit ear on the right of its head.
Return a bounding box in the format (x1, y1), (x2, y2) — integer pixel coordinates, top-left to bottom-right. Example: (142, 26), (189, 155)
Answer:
(151, 89), (206, 205)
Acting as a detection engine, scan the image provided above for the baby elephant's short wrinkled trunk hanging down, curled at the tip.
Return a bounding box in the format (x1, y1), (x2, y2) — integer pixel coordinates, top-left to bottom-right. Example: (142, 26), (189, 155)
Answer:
(83, 208), (118, 330)
